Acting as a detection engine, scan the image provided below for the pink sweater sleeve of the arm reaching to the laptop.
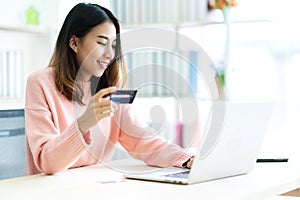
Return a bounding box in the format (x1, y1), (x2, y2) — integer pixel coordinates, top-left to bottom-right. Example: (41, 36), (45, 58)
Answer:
(116, 106), (193, 167)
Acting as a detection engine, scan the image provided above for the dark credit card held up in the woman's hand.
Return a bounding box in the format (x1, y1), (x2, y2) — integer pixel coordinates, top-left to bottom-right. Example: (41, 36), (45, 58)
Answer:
(110, 90), (137, 104)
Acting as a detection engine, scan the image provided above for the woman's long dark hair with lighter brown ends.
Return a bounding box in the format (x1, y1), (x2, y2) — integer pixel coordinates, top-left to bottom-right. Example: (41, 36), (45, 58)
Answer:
(49, 3), (126, 104)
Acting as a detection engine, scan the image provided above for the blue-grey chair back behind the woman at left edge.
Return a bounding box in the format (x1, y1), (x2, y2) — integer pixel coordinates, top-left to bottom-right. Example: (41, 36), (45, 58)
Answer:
(0, 109), (25, 180)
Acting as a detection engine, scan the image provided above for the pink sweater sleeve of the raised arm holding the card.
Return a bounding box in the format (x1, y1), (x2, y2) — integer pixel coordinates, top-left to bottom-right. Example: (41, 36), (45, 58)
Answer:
(25, 71), (87, 174)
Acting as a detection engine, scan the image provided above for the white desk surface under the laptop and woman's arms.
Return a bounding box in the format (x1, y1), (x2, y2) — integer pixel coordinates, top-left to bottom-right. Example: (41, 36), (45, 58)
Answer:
(0, 159), (300, 200)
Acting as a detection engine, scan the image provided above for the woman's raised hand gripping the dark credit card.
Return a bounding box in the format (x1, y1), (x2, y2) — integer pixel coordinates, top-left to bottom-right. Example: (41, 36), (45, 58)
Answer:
(77, 87), (118, 135)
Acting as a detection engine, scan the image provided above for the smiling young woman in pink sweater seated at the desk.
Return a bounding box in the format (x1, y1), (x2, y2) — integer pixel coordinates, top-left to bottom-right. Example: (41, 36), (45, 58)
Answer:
(25, 3), (195, 175)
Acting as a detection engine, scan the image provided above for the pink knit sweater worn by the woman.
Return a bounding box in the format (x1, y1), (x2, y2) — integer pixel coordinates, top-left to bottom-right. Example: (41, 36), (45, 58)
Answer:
(25, 68), (191, 175)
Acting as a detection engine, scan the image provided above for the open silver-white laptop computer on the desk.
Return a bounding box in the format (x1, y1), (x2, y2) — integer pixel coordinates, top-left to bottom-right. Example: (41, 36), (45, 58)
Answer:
(124, 101), (274, 184)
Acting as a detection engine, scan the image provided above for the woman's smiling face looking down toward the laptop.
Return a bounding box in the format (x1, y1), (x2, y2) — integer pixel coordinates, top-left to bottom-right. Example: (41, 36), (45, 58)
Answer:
(76, 21), (116, 81)
